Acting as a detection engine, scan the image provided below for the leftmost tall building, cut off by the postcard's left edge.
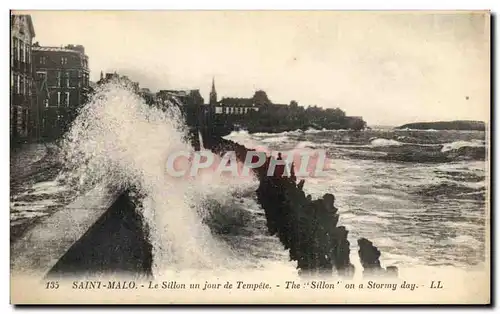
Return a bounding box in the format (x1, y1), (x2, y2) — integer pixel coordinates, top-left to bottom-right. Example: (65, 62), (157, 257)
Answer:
(10, 15), (35, 142)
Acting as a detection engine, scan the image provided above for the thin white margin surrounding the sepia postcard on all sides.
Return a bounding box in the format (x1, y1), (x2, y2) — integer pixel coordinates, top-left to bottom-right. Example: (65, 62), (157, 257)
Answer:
(0, 0), (500, 313)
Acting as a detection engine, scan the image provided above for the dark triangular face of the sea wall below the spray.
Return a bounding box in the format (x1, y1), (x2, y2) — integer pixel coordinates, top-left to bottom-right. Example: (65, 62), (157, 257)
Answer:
(47, 191), (153, 278)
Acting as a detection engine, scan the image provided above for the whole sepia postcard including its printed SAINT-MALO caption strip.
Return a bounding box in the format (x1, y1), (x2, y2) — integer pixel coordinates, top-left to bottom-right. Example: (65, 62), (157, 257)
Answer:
(9, 10), (492, 305)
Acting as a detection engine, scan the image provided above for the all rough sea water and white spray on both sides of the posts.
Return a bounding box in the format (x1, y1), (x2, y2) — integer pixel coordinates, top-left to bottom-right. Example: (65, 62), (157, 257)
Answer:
(11, 85), (489, 275)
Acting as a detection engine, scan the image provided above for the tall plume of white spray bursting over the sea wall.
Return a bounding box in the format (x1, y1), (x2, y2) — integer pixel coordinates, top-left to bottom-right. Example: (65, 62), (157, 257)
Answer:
(62, 84), (252, 275)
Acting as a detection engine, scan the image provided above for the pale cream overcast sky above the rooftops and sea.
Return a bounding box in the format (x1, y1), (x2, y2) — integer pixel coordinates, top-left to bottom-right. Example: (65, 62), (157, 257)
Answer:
(25, 11), (490, 125)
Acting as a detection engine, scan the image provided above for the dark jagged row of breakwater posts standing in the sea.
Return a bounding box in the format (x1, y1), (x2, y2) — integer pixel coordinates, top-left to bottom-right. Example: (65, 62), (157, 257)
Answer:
(206, 134), (397, 277)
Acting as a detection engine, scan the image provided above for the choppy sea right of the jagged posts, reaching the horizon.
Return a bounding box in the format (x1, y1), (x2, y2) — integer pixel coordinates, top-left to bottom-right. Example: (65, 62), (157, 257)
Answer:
(225, 129), (489, 267)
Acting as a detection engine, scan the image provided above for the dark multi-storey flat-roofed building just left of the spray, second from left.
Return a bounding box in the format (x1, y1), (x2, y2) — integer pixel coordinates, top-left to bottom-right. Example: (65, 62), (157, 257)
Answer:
(33, 44), (90, 139)
